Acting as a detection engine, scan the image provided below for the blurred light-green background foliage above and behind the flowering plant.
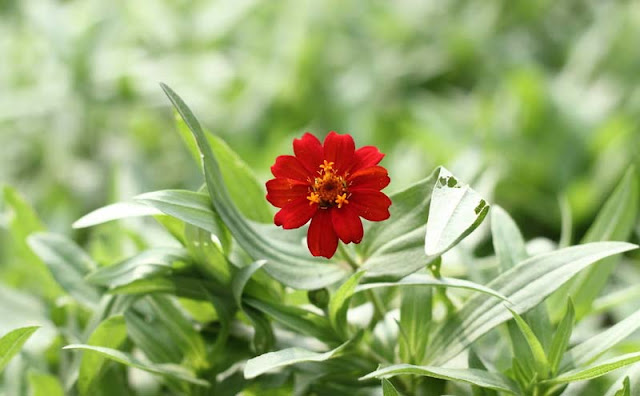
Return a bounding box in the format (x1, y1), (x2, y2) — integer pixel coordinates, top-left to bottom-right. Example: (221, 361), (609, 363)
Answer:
(0, 0), (640, 241)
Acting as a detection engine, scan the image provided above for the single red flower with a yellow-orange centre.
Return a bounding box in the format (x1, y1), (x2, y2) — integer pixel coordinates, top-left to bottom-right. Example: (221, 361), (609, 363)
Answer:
(267, 131), (391, 258)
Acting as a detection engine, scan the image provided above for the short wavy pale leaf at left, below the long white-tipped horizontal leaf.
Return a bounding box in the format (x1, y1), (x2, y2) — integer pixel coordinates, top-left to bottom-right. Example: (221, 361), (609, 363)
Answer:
(86, 248), (190, 287)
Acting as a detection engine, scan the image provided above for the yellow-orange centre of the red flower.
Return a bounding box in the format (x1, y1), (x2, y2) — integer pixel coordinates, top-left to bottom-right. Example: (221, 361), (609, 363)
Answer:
(307, 160), (349, 209)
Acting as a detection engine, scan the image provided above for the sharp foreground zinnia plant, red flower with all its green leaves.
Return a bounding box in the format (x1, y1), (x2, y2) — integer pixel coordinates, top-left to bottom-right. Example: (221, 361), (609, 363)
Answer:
(0, 85), (640, 396)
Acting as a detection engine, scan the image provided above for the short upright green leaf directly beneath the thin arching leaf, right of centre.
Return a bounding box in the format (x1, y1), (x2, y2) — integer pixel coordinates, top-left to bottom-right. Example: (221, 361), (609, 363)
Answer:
(400, 286), (432, 364)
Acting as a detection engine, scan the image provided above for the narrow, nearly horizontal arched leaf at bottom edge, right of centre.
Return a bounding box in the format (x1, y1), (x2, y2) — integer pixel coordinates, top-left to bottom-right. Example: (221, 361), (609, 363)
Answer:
(360, 364), (518, 394)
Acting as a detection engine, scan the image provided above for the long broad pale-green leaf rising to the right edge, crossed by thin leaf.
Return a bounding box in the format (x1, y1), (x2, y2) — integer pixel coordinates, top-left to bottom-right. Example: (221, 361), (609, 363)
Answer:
(429, 242), (637, 364)
